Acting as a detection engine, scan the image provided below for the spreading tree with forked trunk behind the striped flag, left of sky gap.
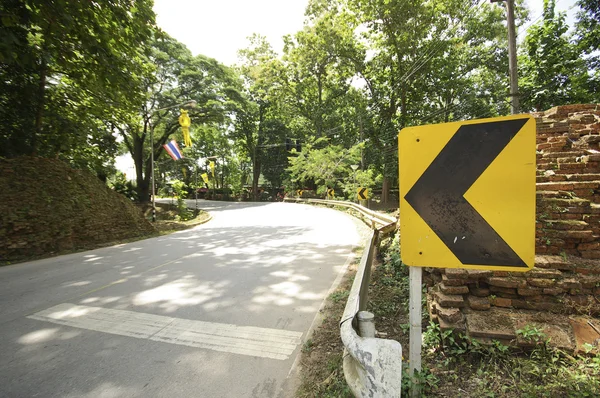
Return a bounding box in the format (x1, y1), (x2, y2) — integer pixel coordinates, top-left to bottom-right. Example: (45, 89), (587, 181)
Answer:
(115, 31), (243, 201)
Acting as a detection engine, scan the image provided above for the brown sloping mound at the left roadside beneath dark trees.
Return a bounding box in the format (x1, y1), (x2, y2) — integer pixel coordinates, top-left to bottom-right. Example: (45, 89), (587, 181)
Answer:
(0, 157), (156, 264)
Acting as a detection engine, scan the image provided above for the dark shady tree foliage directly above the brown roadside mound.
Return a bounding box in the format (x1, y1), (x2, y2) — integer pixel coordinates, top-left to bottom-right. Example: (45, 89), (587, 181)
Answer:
(0, 0), (154, 168)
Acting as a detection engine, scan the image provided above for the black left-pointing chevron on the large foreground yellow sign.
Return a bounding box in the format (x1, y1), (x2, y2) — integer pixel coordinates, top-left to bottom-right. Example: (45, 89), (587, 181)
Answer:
(404, 119), (528, 267)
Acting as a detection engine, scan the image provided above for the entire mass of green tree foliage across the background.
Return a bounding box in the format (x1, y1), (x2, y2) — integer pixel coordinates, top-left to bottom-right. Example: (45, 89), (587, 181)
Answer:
(0, 0), (600, 204)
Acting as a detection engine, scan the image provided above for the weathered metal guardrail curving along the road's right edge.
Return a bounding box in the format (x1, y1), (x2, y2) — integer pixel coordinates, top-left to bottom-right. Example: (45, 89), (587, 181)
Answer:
(287, 199), (402, 398)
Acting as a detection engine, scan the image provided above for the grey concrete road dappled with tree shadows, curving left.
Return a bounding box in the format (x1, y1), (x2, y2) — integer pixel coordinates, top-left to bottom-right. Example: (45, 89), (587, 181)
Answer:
(0, 201), (362, 398)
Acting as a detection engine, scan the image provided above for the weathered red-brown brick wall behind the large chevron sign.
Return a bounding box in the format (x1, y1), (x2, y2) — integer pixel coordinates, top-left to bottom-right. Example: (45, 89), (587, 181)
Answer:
(424, 104), (600, 330)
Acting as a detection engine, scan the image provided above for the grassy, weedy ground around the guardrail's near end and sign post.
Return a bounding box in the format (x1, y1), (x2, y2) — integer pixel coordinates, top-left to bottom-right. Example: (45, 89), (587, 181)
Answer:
(298, 232), (600, 398)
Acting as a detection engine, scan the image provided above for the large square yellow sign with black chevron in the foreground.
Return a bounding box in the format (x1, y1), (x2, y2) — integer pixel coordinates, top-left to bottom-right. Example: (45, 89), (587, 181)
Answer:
(398, 115), (536, 271)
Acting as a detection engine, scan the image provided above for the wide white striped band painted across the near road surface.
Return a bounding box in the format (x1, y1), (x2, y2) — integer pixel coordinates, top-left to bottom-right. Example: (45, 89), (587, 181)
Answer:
(27, 303), (302, 360)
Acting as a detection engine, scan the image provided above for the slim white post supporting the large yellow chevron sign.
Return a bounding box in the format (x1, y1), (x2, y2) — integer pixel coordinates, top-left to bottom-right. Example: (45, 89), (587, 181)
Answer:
(408, 267), (423, 397)
